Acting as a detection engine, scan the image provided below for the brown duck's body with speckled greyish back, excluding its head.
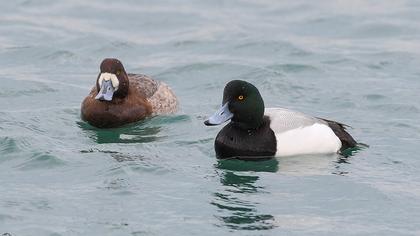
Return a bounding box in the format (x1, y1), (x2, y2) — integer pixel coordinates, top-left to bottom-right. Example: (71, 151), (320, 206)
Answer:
(81, 74), (177, 128)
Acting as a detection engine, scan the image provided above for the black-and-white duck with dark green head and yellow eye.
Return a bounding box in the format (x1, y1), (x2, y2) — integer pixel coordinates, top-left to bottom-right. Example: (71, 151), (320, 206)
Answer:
(204, 80), (357, 159)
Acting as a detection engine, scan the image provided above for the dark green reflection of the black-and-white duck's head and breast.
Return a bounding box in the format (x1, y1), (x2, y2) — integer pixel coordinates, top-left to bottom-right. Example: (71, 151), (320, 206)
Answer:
(211, 159), (278, 230)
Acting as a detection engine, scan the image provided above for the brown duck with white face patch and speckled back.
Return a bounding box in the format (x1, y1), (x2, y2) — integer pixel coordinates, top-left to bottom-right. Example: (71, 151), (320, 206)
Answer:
(81, 58), (178, 128)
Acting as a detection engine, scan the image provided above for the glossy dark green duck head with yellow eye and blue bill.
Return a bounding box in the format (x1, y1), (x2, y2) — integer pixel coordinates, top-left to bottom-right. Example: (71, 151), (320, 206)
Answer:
(204, 80), (264, 129)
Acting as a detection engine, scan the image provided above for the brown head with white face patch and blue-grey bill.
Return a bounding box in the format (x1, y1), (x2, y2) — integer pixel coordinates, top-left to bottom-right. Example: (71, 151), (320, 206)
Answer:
(95, 58), (129, 101)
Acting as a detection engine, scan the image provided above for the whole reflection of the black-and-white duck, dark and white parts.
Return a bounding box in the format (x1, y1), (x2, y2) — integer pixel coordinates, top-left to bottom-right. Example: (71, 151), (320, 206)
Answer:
(211, 150), (357, 230)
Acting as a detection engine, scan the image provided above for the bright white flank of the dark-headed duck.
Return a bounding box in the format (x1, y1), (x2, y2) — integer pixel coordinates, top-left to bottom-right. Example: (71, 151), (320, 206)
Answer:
(275, 123), (341, 156)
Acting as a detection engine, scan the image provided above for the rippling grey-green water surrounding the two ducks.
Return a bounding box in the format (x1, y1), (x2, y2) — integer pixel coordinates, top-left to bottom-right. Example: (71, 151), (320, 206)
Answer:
(0, 0), (420, 236)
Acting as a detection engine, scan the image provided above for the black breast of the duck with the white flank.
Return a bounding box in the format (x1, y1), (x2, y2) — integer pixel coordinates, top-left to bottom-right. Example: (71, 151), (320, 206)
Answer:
(214, 117), (277, 159)
